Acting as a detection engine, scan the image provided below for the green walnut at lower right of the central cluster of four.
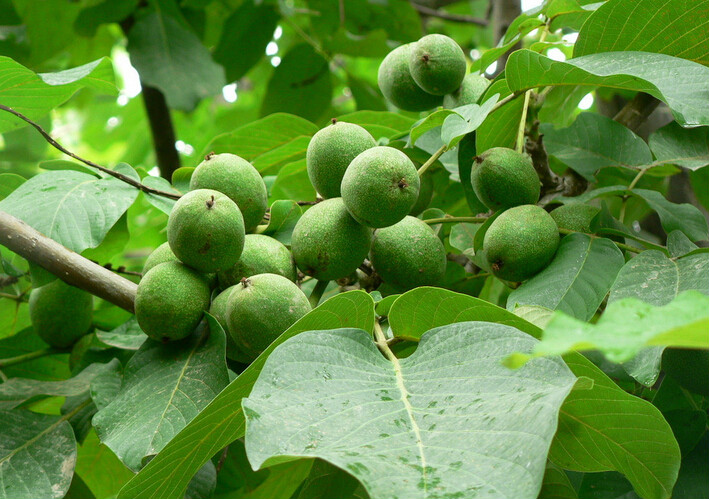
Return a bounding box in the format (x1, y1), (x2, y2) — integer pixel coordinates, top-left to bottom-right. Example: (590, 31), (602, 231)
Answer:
(370, 216), (446, 291)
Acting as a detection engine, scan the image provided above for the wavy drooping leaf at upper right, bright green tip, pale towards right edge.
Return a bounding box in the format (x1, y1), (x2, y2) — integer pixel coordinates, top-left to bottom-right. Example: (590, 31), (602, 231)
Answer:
(505, 49), (709, 126)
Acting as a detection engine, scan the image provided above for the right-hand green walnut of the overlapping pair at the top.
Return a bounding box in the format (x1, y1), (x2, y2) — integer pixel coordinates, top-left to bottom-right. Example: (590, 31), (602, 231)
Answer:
(409, 34), (466, 95)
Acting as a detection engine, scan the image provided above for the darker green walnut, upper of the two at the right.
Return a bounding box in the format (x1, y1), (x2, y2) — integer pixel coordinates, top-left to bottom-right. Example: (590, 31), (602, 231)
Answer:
(470, 147), (540, 211)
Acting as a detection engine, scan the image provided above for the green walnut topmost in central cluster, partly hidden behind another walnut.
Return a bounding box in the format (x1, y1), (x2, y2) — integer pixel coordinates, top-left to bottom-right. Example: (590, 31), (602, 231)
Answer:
(306, 120), (377, 199)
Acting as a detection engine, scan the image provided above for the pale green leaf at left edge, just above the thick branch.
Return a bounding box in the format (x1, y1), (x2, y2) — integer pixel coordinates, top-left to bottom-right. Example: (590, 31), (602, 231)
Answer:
(0, 169), (138, 253)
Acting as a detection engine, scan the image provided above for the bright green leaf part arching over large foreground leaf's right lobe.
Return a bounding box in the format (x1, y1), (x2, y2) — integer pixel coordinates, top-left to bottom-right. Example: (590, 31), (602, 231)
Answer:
(389, 287), (541, 340)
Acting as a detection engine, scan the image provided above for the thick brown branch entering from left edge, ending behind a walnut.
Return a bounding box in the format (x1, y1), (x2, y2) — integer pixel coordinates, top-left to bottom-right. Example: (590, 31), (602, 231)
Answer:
(0, 211), (138, 313)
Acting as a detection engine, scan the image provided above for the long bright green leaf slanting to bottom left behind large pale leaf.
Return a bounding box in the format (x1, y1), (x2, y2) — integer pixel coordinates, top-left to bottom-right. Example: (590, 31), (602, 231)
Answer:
(118, 291), (374, 499)
